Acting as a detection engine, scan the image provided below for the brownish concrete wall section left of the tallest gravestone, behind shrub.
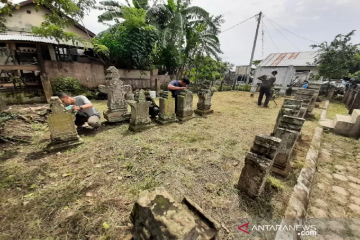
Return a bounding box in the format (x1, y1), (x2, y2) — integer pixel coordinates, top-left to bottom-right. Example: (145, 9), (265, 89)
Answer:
(45, 61), (105, 89)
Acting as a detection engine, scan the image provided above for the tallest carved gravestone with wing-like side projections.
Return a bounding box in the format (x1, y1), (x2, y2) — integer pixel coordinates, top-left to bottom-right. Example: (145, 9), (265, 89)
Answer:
(99, 66), (131, 122)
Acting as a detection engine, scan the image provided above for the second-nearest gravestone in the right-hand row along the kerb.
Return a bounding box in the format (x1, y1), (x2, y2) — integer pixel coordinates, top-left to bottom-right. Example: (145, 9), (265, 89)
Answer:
(272, 128), (300, 177)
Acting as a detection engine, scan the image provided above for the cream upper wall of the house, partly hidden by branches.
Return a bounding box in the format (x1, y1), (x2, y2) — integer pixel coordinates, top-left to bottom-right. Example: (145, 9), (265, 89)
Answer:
(4, 4), (91, 45)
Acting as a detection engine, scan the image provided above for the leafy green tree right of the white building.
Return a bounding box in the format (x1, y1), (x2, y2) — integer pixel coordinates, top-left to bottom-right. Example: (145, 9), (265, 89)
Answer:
(311, 30), (360, 79)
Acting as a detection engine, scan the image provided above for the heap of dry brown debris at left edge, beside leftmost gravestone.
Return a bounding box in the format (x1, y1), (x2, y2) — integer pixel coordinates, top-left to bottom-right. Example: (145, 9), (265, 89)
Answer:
(0, 104), (49, 143)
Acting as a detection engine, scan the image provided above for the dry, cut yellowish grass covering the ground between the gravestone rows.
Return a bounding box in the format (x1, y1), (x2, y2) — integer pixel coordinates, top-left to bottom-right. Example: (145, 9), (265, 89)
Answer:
(0, 92), (316, 239)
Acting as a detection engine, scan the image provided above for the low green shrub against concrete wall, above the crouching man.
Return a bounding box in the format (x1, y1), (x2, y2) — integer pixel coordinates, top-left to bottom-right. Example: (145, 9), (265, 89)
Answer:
(51, 75), (85, 95)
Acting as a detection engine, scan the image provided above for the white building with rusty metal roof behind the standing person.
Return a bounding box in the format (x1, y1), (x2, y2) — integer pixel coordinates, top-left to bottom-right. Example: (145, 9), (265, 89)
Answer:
(251, 52), (318, 94)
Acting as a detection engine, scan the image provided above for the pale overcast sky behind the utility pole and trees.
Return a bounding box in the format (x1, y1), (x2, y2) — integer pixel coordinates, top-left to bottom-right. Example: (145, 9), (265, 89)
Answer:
(15, 0), (360, 66)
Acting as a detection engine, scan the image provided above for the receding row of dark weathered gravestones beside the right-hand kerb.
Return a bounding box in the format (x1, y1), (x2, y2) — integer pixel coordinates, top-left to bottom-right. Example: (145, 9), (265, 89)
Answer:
(237, 89), (319, 197)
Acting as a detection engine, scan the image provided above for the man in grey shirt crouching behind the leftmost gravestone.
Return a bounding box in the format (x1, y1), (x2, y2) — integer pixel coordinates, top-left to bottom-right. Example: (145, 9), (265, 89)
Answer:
(56, 92), (100, 130)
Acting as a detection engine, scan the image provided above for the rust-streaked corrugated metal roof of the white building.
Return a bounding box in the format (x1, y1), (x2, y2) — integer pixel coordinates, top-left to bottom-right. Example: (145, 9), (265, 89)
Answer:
(259, 52), (317, 67)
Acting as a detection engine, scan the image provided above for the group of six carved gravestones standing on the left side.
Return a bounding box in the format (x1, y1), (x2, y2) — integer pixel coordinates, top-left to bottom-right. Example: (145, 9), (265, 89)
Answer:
(45, 66), (213, 151)
